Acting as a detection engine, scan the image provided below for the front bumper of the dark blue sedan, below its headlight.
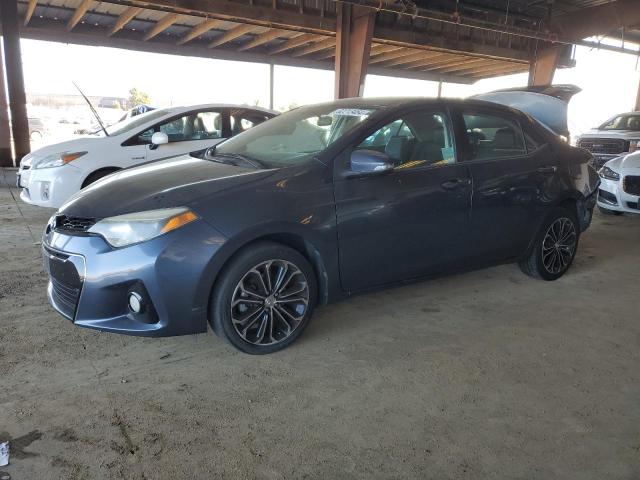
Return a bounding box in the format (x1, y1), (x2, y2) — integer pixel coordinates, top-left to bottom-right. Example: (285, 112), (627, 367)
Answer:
(43, 220), (226, 336)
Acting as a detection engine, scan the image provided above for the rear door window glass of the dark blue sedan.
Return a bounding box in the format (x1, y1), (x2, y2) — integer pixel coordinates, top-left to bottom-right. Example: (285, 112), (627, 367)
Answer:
(463, 113), (526, 160)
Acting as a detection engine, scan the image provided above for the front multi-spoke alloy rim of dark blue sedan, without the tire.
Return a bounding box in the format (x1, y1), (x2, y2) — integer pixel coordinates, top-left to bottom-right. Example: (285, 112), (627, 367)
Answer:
(231, 259), (309, 346)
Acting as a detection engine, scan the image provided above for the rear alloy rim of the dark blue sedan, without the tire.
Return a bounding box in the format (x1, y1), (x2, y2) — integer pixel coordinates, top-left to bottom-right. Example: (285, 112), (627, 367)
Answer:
(542, 217), (578, 275)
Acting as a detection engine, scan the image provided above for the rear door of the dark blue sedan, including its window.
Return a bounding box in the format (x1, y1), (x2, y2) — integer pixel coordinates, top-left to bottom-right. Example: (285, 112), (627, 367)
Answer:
(456, 107), (558, 263)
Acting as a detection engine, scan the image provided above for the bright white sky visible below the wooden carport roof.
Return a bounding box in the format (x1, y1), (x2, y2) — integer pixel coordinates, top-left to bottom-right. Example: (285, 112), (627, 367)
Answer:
(21, 39), (640, 134)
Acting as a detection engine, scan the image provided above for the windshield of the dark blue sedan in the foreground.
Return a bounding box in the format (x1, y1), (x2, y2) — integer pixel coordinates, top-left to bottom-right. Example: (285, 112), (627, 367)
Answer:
(215, 104), (377, 168)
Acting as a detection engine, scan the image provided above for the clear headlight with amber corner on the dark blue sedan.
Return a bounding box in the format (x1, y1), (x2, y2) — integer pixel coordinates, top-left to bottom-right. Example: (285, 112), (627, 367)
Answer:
(88, 207), (198, 247)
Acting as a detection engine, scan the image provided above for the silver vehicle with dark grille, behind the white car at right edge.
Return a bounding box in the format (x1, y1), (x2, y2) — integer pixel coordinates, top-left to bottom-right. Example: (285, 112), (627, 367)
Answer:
(576, 112), (640, 170)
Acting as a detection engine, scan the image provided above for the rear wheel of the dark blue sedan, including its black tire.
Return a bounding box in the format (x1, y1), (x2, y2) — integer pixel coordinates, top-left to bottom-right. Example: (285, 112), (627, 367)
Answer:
(519, 207), (580, 281)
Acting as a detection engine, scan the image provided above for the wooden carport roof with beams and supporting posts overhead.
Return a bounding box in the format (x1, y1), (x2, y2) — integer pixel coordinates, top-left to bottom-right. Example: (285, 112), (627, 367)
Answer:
(0, 0), (640, 166)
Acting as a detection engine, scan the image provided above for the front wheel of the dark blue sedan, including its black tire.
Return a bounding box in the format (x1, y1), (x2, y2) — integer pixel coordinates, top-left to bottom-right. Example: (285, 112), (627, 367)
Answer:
(209, 242), (317, 355)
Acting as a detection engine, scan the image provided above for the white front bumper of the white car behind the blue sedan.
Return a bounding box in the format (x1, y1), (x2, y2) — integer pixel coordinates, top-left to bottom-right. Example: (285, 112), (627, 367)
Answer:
(16, 165), (84, 208)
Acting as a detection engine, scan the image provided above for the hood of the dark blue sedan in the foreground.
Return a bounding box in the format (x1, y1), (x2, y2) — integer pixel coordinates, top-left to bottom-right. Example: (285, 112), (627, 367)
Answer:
(60, 155), (273, 218)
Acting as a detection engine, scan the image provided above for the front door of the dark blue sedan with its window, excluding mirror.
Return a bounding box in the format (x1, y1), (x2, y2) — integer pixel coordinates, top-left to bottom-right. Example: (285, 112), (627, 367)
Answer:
(334, 110), (471, 291)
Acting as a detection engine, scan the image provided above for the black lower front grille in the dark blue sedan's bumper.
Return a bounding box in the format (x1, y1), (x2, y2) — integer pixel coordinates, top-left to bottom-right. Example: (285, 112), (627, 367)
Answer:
(43, 248), (82, 319)
